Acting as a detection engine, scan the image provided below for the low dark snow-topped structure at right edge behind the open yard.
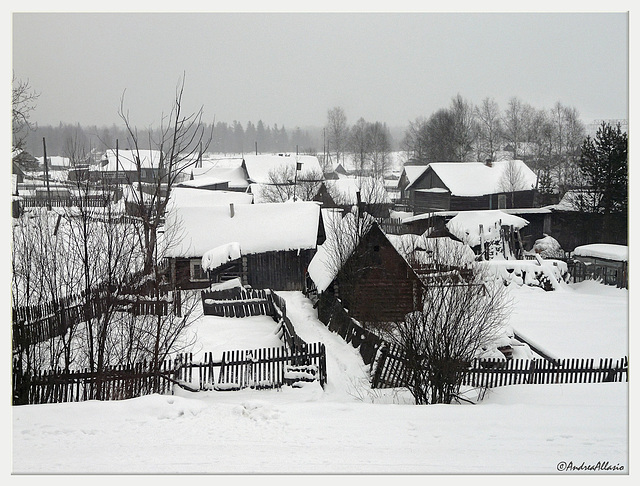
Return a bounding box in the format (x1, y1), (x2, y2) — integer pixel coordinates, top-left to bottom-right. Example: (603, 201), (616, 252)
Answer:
(571, 243), (629, 288)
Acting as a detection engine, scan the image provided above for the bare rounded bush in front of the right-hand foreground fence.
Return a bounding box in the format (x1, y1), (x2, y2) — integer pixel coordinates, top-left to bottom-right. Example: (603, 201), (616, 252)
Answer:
(385, 258), (509, 404)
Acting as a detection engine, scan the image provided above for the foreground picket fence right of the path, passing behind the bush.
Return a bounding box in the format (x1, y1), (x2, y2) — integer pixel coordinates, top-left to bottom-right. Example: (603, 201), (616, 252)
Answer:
(371, 345), (629, 388)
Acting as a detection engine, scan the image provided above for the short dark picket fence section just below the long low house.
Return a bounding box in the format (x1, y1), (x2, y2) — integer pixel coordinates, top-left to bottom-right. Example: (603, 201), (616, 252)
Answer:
(201, 287), (274, 317)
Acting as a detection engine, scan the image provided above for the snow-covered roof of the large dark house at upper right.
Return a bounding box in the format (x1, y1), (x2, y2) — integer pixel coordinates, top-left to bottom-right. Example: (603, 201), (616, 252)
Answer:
(429, 160), (537, 196)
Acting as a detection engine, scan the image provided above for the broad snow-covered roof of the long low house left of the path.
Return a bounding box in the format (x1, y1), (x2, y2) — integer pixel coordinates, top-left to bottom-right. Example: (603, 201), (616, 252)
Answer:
(166, 202), (320, 258)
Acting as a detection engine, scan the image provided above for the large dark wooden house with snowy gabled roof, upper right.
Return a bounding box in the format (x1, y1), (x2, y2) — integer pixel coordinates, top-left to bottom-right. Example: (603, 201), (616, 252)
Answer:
(403, 160), (537, 214)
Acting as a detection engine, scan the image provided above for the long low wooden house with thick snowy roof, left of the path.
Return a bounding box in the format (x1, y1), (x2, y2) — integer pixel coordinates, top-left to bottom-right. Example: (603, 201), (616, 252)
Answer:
(166, 202), (324, 290)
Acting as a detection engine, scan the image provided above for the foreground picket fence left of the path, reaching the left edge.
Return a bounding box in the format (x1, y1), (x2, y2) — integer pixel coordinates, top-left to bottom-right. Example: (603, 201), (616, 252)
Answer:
(13, 343), (327, 405)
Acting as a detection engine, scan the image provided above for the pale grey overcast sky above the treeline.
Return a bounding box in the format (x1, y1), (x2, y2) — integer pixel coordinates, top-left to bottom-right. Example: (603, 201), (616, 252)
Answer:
(12, 13), (629, 129)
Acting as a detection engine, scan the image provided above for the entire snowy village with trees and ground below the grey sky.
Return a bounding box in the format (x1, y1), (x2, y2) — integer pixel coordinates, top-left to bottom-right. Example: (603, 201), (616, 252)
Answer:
(10, 10), (630, 475)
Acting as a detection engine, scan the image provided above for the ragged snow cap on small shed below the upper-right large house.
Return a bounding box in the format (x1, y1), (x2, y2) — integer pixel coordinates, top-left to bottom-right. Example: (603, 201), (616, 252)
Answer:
(446, 209), (529, 247)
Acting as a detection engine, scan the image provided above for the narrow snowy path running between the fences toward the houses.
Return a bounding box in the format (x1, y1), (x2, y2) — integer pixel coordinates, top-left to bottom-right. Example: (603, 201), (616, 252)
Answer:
(277, 292), (371, 400)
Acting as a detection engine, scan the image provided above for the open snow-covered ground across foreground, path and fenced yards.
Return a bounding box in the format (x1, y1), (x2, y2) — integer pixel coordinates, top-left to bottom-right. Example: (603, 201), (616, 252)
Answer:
(11, 282), (629, 475)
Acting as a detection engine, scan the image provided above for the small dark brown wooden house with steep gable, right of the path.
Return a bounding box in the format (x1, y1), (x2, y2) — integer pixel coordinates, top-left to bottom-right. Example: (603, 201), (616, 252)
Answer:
(309, 217), (422, 326)
